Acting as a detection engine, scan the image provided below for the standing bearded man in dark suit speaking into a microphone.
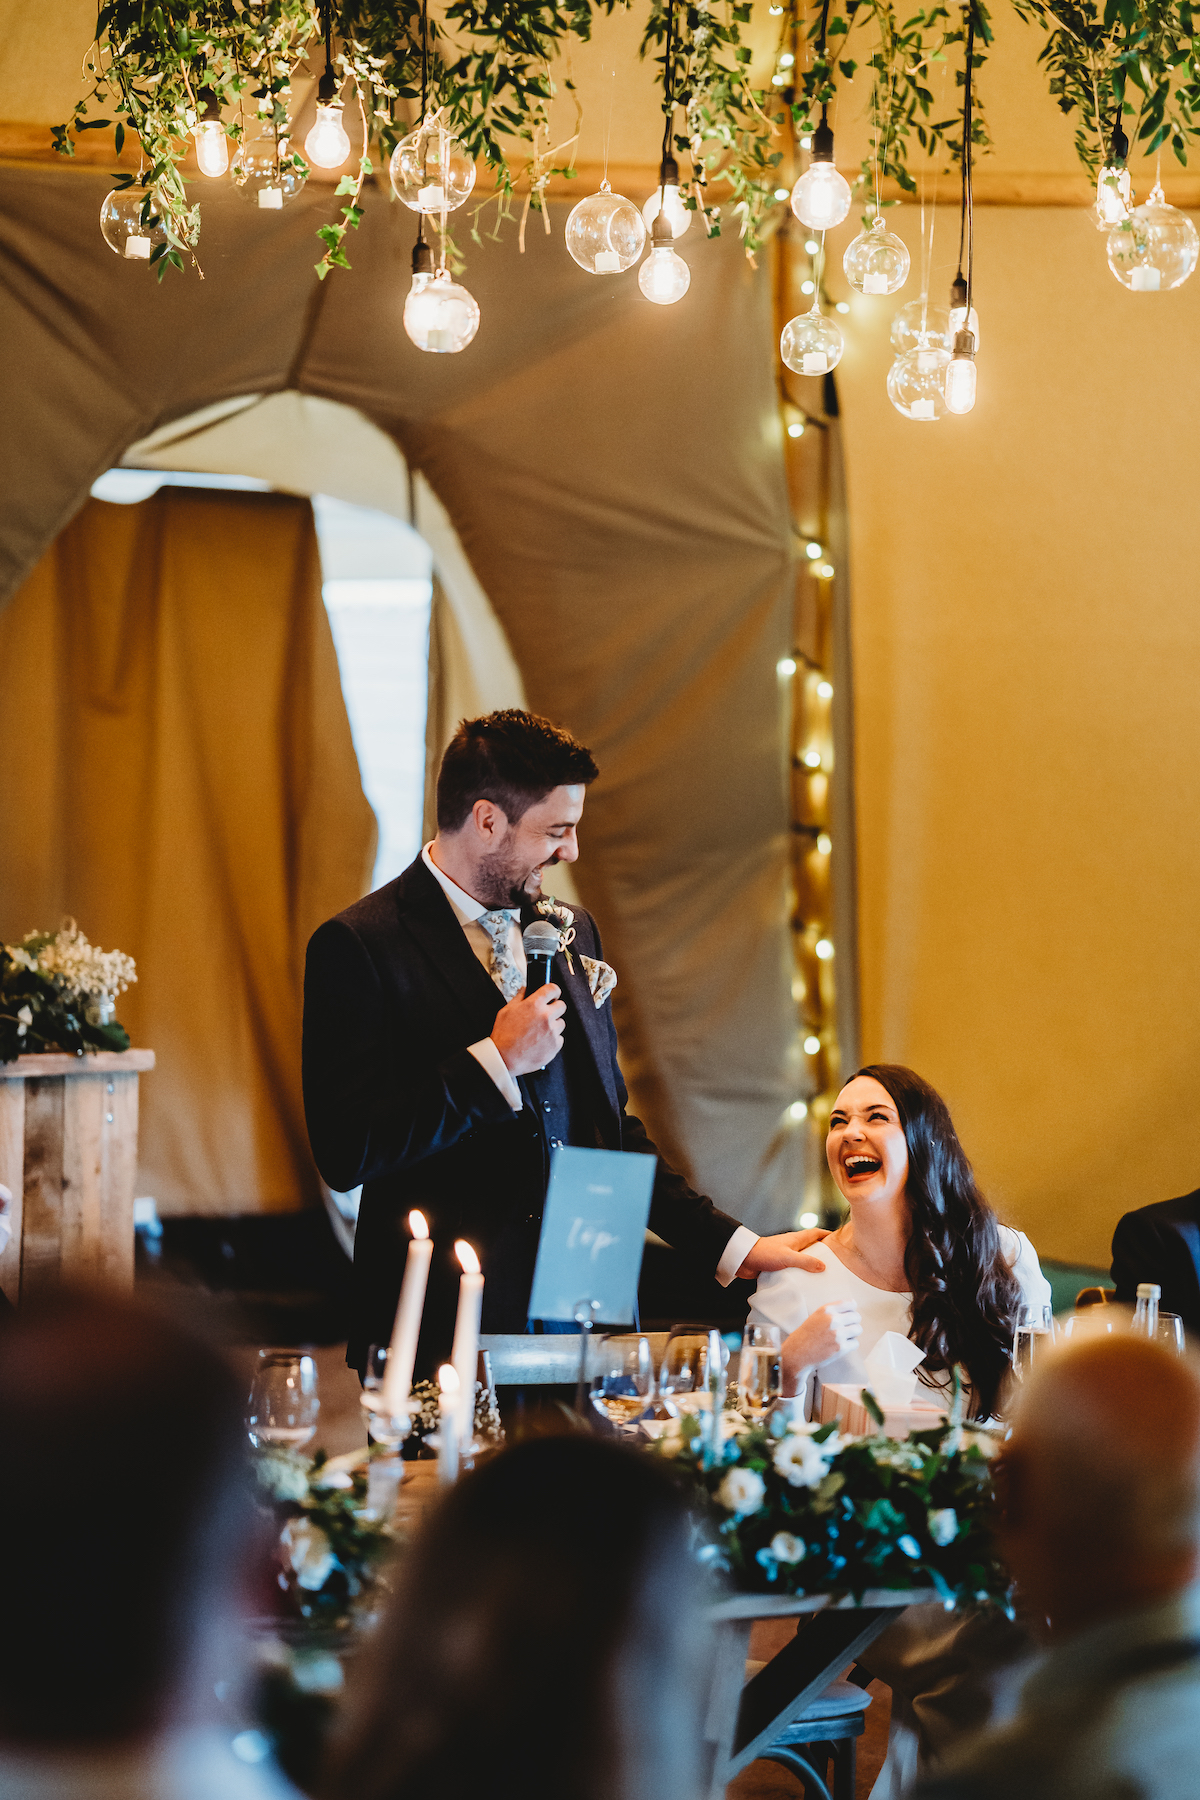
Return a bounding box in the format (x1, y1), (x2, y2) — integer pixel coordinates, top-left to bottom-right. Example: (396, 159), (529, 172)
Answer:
(304, 711), (822, 1375)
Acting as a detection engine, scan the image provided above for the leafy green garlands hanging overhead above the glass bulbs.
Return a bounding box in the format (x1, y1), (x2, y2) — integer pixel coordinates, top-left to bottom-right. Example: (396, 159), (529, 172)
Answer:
(54, 0), (1200, 277)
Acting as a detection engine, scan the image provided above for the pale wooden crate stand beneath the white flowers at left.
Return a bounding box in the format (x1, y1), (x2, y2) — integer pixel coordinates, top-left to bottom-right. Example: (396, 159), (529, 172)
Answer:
(0, 1049), (155, 1305)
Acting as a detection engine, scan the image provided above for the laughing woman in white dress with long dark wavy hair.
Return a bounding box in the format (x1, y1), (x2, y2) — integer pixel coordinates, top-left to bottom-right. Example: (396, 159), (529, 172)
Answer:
(750, 1062), (1051, 1418)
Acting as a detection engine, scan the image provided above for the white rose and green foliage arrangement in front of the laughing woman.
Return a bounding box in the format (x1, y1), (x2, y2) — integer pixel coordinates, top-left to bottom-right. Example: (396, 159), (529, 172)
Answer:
(651, 1393), (1011, 1613)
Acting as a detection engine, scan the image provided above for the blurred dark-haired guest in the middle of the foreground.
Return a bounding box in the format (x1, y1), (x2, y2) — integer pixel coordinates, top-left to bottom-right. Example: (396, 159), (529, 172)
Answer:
(326, 1436), (703, 1800)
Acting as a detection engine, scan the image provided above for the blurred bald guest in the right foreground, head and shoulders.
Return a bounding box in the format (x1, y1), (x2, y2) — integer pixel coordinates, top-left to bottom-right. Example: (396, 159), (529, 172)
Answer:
(919, 1332), (1200, 1800)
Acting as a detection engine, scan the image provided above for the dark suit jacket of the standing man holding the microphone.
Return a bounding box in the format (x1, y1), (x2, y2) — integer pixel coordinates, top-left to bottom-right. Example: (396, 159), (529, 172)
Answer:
(304, 857), (738, 1373)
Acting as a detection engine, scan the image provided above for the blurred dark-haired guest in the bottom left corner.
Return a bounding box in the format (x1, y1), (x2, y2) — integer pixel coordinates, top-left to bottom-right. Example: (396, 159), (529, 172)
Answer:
(0, 1292), (293, 1800)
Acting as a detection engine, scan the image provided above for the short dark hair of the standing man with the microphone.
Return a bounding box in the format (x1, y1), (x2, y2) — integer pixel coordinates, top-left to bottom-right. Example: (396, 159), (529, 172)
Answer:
(437, 707), (599, 832)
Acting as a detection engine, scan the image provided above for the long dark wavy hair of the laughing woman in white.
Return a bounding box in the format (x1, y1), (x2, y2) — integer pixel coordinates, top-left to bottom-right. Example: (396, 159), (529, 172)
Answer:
(851, 1062), (1020, 1418)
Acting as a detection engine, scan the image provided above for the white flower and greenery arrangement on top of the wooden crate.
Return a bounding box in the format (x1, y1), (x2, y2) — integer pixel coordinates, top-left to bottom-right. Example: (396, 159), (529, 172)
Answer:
(0, 918), (137, 1062)
